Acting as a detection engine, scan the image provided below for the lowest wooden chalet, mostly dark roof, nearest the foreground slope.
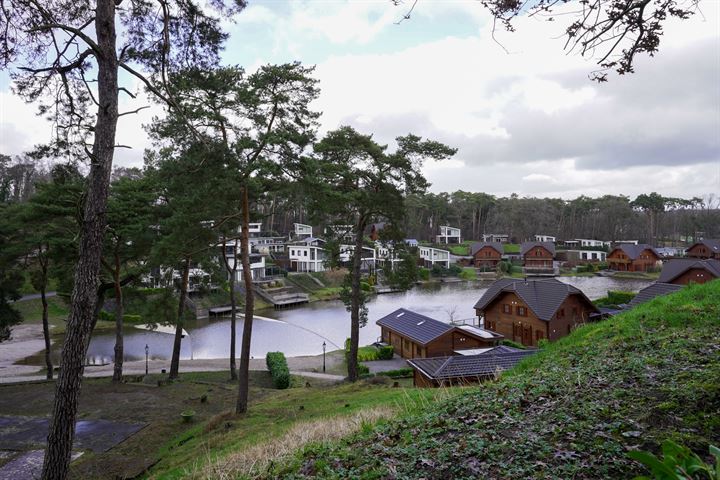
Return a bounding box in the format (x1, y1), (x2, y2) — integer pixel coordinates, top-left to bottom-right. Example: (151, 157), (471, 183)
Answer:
(408, 346), (535, 387)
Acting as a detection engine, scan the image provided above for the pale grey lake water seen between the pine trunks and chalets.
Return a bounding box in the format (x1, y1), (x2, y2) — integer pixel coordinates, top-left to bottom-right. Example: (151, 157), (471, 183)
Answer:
(88, 277), (650, 360)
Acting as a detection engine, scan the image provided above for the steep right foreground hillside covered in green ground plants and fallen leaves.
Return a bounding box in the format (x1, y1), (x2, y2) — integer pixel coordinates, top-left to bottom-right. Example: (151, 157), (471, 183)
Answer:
(265, 281), (720, 479)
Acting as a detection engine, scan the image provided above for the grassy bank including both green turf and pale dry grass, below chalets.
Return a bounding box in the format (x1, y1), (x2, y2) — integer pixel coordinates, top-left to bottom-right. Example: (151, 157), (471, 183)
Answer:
(147, 379), (451, 479)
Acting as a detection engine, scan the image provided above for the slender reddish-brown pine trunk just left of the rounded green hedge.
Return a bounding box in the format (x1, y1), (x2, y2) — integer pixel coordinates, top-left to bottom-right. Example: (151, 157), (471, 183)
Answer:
(235, 186), (255, 413)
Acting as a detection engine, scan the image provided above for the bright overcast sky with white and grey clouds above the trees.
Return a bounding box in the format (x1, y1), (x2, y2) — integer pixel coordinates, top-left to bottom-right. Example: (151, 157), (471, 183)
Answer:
(0, 0), (720, 198)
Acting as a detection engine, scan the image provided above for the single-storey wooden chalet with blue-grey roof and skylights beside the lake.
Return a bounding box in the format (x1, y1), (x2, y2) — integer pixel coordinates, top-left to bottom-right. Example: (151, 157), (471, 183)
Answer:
(376, 308), (503, 358)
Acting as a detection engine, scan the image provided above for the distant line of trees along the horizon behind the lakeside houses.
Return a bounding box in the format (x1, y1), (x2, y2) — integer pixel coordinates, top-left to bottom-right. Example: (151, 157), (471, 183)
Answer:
(0, 154), (720, 245)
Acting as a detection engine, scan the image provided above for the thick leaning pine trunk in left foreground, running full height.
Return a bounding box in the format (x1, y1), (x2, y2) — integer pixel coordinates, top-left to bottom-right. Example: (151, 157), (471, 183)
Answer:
(42, 0), (118, 480)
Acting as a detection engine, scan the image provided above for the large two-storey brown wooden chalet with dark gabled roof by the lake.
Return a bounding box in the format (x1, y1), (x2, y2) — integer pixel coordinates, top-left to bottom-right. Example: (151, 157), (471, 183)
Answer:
(475, 278), (600, 346)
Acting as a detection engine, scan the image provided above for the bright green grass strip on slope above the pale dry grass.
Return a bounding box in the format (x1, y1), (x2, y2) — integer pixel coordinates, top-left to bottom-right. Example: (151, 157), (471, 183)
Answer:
(149, 379), (456, 479)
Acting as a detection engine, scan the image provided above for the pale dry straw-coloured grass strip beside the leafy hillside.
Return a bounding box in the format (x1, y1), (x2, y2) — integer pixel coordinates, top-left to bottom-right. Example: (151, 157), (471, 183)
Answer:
(192, 407), (395, 480)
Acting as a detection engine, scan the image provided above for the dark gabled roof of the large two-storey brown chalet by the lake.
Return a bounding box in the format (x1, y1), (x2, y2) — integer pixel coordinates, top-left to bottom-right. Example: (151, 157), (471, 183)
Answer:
(475, 278), (598, 321)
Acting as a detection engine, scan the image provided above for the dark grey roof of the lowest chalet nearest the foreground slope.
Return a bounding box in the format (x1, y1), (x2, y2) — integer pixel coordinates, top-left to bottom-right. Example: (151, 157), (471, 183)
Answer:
(407, 349), (535, 380)
